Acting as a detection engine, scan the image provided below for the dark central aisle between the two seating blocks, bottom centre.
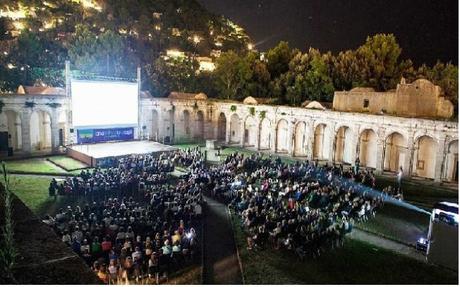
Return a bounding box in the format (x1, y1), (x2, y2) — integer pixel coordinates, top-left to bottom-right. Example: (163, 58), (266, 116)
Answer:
(203, 197), (242, 284)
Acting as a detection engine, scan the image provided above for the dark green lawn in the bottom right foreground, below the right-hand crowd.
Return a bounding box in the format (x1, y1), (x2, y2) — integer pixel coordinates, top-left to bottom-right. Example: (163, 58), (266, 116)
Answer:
(233, 217), (458, 284)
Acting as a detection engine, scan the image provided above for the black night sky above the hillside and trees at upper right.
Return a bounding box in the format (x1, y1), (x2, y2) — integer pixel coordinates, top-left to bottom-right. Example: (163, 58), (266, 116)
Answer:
(198, 0), (458, 64)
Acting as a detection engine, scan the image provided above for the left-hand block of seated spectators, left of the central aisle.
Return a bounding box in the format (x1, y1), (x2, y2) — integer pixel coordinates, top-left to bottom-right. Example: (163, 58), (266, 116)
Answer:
(46, 150), (202, 284)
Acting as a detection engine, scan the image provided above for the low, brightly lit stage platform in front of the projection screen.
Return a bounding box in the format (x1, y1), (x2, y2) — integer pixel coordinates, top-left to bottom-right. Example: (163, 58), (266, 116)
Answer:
(67, 141), (178, 167)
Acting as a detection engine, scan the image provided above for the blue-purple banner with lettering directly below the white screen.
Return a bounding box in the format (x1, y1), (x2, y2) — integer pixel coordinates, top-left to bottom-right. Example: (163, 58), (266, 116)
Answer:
(77, 128), (134, 144)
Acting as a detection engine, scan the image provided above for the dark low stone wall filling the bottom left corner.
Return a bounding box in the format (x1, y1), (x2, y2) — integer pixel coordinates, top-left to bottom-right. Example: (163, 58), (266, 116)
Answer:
(0, 186), (101, 285)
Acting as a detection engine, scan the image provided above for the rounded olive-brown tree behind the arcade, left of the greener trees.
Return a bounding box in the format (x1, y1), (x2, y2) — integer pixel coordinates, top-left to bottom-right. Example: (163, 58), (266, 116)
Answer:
(214, 51), (252, 99)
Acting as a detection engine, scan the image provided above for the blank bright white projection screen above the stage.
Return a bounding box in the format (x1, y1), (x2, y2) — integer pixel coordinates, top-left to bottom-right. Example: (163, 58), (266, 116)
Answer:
(71, 80), (139, 128)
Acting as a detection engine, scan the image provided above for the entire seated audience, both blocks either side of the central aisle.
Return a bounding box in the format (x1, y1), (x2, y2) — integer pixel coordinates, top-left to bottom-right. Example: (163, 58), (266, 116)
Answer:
(45, 149), (392, 284)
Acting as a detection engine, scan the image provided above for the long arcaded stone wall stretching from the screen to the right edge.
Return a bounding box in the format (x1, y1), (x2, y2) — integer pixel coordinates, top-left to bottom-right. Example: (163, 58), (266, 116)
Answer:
(141, 98), (458, 181)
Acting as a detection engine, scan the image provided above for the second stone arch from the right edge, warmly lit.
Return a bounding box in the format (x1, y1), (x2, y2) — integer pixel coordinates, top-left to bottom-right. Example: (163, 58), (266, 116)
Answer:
(412, 136), (438, 179)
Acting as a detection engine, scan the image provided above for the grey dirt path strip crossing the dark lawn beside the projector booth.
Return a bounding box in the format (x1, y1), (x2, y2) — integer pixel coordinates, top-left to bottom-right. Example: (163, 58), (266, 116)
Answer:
(348, 228), (426, 262)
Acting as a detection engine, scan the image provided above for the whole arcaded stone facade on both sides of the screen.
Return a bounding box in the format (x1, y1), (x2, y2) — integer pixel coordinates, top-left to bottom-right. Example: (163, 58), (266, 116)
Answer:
(0, 83), (458, 181)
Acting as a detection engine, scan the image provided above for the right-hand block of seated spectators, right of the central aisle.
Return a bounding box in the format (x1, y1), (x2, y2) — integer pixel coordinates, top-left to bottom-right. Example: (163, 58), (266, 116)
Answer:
(201, 153), (382, 259)
